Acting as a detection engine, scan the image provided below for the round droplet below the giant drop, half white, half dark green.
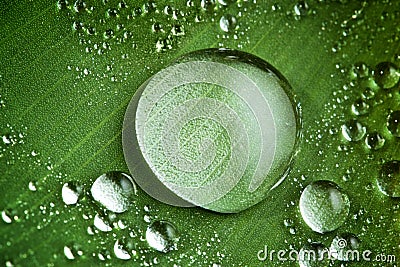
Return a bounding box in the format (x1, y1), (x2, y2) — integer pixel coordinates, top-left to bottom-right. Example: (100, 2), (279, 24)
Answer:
(146, 221), (178, 253)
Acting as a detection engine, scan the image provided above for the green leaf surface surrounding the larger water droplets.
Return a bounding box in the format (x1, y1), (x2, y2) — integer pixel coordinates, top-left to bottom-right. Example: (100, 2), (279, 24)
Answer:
(0, 0), (400, 266)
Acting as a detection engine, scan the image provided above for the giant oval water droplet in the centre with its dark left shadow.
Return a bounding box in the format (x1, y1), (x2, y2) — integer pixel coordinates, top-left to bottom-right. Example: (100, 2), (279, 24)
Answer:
(123, 49), (301, 215)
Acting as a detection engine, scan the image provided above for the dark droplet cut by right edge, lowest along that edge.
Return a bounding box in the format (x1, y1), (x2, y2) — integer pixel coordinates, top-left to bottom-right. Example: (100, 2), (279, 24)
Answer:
(377, 160), (400, 197)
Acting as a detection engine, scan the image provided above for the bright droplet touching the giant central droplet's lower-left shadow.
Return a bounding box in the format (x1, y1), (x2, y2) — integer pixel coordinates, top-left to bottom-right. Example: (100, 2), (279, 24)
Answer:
(90, 171), (136, 213)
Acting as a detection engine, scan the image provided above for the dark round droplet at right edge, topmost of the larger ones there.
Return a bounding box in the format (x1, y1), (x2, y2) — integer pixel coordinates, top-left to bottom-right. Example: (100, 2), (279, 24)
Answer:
(374, 62), (400, 89)
